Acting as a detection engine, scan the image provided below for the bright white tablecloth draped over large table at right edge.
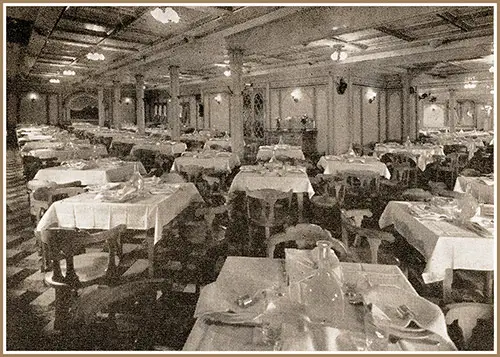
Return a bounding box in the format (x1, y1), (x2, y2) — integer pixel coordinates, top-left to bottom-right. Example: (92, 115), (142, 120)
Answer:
(379, 201), (496, 284)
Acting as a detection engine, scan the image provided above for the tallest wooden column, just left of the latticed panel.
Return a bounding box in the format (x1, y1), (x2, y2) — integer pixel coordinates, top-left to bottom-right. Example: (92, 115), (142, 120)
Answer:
(229, 49), (245, 159)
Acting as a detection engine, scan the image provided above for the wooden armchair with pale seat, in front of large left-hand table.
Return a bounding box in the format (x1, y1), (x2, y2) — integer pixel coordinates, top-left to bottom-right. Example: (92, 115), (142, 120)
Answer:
(40, 224), (126, 331)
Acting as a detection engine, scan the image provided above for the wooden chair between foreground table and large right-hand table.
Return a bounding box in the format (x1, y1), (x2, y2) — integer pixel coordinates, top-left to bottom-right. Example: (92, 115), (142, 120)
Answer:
(341, 210), (399, 265)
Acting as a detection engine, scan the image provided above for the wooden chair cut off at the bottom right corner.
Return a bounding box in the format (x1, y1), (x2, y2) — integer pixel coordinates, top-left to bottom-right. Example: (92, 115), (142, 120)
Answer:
(445, 303), (494, 350)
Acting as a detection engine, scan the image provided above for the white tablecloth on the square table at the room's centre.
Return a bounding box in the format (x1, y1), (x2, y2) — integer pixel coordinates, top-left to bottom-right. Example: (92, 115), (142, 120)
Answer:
(229, 171), (314, 198)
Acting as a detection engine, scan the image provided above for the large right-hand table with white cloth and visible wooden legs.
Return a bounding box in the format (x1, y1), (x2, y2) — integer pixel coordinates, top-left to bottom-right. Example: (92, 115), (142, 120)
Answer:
(379, 197), (496, 300)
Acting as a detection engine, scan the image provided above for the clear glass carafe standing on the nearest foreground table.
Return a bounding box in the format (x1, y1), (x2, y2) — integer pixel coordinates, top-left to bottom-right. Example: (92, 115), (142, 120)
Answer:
(299, 240), (344, 325)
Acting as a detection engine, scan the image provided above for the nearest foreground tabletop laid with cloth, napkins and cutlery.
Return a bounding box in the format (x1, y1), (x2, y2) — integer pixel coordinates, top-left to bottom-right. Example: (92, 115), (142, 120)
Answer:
(184, 249), (455, 351)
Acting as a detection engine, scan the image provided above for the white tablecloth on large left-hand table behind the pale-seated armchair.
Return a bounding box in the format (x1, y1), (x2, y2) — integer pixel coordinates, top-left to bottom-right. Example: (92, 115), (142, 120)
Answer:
(36, 183), (203, 244)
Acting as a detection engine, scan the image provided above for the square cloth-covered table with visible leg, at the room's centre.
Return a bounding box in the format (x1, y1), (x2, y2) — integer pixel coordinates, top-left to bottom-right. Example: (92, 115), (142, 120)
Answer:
(229, 161), (314, 222)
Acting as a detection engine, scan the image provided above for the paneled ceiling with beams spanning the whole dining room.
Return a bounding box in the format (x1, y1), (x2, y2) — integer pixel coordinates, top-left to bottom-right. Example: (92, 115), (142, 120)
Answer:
(6, 5), (494, 93)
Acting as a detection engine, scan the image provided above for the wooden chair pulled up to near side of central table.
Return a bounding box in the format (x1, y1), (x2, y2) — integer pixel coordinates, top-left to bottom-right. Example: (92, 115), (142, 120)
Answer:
(246, 189), (293, 254)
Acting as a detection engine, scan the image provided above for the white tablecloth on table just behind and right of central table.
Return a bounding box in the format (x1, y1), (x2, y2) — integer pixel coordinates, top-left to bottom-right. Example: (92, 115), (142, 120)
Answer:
(317, 156), (391, 179)
